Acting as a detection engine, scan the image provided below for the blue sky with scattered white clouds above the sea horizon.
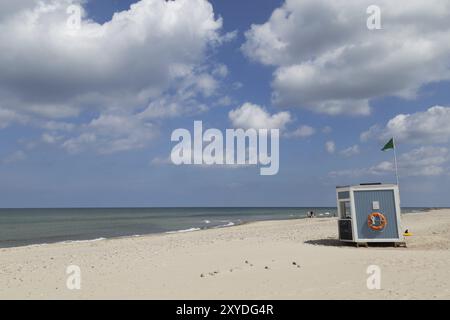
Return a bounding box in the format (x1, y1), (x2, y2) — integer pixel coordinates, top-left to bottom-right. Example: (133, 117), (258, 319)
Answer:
(0, 0), (450, 208)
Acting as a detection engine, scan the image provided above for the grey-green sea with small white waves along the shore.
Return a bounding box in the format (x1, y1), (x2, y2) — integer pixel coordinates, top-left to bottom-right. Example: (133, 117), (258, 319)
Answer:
(0, 207), (423, 248)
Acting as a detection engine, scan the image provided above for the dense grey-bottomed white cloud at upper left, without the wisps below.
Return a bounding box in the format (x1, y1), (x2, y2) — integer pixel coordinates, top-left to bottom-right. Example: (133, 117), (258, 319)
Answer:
(0, 0), (222, 117)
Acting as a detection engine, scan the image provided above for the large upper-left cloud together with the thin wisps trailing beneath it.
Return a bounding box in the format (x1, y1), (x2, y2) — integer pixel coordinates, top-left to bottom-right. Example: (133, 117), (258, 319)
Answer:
(0, 0), (227, 152)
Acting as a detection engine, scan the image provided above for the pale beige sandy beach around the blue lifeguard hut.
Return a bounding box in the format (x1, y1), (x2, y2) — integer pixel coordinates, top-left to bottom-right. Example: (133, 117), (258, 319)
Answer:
(0, 209), (450, 299)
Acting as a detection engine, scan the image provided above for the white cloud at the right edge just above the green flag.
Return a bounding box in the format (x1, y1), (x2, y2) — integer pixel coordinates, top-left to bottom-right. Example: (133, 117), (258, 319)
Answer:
(361, 106), (450, 144)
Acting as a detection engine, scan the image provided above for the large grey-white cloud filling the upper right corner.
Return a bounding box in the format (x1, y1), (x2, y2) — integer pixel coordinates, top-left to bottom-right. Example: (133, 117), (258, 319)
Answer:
(242, 0), (450, 115)
